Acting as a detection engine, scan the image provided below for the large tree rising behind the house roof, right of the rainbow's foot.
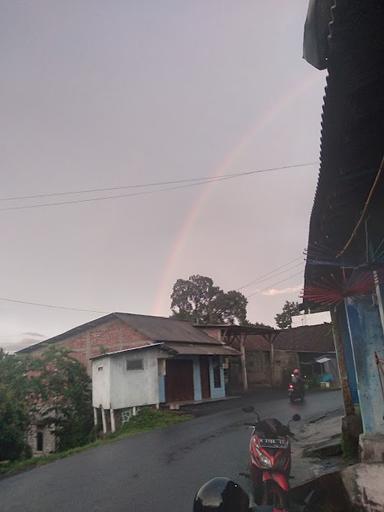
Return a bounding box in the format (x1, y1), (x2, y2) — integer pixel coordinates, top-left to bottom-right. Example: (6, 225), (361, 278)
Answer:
(171, 275), (248, 324)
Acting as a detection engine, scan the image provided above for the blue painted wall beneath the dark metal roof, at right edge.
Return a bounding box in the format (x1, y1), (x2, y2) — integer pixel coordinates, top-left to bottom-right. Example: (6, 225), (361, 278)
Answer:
(346, 296), (384, 433)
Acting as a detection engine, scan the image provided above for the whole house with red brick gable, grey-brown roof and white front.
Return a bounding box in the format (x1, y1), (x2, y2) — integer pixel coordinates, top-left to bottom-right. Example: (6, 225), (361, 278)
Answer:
(18, 313), (240, 440)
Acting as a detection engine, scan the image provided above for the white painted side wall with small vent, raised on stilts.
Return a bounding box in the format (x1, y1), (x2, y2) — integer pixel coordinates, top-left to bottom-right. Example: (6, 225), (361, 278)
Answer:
(92, 349), (164, 409)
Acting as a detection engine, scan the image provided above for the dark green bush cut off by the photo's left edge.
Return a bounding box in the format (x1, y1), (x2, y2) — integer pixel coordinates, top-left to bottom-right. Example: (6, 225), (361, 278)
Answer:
(0, 349), (30, 460)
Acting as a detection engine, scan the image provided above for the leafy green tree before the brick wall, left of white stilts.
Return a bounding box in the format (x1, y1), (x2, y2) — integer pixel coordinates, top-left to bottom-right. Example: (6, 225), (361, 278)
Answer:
(30, 347), (93, 451)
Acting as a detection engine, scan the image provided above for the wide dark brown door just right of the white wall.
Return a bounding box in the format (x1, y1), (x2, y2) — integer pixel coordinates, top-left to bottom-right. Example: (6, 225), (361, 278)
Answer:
(165, 359), (194, 402)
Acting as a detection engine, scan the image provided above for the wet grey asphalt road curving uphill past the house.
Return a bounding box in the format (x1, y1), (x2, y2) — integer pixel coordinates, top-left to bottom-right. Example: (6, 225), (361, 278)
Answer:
(0, 391), (341, 512)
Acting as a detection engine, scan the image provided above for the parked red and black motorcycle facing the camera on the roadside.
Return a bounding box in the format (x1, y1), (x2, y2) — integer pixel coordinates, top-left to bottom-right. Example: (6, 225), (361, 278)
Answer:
(243, 407), (301, 511)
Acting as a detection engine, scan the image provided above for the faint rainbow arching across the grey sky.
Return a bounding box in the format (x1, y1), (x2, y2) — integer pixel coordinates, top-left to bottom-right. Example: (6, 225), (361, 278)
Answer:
(152, 72), (323, 315)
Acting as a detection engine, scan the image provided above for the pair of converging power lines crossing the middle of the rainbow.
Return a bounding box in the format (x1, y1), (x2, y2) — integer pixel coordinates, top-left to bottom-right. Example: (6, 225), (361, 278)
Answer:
(0, 162), (317, 211)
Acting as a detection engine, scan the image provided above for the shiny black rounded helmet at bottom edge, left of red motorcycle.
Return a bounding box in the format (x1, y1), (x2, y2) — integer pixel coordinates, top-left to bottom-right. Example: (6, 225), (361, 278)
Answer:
(193, 477), (250, 512)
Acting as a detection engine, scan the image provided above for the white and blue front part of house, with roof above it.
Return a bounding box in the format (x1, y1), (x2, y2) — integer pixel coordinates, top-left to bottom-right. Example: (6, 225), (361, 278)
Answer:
(91, 317), (240, 432)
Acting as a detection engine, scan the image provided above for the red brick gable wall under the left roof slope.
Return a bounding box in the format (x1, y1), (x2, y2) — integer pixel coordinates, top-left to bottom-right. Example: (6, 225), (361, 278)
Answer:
(27, 318), (150, 374)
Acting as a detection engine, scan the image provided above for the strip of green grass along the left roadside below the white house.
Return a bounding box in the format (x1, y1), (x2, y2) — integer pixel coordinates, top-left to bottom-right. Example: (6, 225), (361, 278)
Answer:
(0, 408), (193, 478)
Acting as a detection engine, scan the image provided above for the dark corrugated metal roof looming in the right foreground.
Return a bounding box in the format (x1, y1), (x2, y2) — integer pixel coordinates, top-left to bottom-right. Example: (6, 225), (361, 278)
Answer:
(304, 0), (384, 302)
